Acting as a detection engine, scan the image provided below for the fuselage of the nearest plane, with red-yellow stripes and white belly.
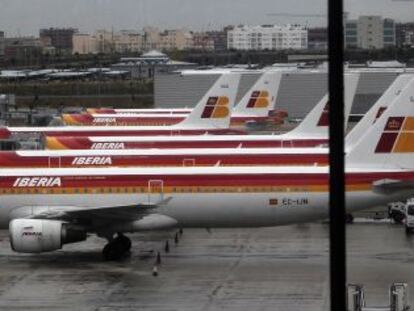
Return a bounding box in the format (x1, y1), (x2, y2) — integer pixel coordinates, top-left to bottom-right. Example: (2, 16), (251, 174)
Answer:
(0, 167), (414, 231)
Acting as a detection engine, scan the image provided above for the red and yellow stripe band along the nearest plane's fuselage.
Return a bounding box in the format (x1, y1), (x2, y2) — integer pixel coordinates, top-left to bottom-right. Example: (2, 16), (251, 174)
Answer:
(0, 172), (414, 195)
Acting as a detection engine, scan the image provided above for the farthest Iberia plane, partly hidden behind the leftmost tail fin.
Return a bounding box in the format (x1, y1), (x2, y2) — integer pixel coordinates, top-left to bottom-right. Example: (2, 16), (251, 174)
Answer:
(62, 71), (283, 127)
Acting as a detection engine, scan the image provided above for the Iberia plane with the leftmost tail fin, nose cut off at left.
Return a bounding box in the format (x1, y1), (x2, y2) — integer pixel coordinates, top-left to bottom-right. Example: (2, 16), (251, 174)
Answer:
(0, 73), (245, 139)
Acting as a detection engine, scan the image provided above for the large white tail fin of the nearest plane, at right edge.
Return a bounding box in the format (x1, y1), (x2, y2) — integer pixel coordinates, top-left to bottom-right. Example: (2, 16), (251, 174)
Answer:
(347, 79), (414, 169)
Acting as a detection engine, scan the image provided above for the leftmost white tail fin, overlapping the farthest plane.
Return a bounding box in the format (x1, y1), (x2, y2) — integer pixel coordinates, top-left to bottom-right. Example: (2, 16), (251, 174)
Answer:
(173, 73), (240, 128)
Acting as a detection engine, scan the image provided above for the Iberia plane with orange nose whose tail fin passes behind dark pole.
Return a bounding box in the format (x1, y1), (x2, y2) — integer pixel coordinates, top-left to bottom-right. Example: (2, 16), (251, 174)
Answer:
(44, 73), (359, 150)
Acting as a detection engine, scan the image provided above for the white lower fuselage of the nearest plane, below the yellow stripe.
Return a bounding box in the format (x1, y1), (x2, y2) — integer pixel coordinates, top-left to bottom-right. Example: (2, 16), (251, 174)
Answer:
(0, 191), (402, 229)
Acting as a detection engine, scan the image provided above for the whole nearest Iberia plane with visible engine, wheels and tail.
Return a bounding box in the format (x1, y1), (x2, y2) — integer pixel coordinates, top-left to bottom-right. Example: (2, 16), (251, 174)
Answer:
(4, 76), (414, 259)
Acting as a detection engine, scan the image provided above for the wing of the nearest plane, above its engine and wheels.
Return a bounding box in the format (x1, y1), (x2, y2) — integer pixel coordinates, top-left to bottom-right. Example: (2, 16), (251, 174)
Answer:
(28, 197), (172, 222)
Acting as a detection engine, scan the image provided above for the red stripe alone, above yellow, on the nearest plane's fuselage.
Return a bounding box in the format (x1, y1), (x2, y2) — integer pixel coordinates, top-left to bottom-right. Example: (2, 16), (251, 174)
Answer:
(0, 171), (414, 192)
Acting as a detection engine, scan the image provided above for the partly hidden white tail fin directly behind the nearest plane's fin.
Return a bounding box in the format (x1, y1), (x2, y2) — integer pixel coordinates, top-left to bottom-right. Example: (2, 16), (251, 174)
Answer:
(346, 74), (414, 151)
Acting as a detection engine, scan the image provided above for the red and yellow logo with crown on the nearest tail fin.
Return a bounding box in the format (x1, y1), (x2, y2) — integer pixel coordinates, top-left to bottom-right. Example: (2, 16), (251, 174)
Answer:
(375, 117), (414, 153)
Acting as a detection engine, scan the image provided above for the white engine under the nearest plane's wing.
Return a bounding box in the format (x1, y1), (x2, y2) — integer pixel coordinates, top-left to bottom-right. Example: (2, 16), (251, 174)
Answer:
(9, 219), (86, 253)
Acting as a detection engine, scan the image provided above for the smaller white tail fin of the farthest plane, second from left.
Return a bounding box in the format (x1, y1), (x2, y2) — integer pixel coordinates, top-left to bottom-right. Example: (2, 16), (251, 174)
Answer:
(232, 71), (282, 117)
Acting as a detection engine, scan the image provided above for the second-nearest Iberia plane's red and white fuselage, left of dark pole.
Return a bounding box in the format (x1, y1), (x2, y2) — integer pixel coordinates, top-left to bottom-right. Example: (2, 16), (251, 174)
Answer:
(0, 148), (328, 168)
